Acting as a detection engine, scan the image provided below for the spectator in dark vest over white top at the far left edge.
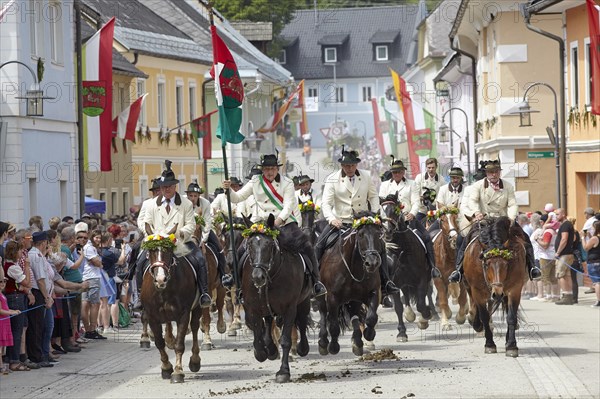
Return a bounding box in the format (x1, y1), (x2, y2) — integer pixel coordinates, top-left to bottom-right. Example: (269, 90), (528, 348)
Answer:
(3, 241), (35, 371)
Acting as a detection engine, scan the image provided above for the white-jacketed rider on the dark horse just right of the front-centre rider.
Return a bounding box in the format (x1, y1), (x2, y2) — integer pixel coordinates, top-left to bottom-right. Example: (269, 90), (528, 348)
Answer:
(379, 157), (442, 278)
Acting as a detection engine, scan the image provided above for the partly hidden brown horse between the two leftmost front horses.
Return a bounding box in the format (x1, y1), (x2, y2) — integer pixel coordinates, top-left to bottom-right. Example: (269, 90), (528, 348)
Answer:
(193, 224), (227, 350)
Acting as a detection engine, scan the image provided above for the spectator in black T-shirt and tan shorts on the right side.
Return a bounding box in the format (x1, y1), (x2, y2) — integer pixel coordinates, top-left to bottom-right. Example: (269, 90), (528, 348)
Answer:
(554, 208), (575, 305)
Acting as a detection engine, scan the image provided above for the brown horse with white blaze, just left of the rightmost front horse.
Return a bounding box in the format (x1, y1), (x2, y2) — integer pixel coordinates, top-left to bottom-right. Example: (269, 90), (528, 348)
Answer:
(433, 207), (467, 331)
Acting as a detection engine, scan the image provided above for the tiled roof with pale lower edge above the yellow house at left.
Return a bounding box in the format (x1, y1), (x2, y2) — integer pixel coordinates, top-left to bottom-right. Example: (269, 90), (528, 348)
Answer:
(79, 0), (212, 65)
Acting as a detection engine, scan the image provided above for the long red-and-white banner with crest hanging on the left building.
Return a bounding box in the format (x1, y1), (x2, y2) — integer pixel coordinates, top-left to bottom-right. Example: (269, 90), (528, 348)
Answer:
(82, 17), (115, 172)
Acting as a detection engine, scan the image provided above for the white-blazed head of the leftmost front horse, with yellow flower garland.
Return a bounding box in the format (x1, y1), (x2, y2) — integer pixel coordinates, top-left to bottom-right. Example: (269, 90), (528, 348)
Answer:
(142, 223), (177, 290)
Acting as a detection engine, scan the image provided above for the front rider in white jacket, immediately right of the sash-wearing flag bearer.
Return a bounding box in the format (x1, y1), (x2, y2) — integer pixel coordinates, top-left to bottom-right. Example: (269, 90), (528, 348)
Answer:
(315, 146), (398, 295)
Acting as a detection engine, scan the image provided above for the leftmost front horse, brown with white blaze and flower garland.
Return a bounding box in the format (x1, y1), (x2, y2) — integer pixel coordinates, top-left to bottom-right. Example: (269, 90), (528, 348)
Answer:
(141, 225), (202, 383)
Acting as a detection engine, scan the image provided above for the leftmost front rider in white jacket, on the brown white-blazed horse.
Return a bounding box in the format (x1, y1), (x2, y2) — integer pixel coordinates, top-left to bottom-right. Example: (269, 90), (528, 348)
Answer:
(138, 160), (211, 308)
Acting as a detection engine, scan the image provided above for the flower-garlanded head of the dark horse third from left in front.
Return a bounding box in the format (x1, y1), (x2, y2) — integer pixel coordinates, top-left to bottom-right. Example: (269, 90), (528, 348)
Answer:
(352, 211), (385, 273)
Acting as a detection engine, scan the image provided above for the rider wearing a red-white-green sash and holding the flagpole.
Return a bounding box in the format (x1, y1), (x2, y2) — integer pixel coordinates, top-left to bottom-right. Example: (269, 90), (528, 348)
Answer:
(223, 154), (327, 296)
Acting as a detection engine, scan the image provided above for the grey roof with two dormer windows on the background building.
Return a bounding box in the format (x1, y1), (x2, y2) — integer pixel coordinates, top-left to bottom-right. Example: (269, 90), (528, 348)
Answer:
(281, 5), (418, 80)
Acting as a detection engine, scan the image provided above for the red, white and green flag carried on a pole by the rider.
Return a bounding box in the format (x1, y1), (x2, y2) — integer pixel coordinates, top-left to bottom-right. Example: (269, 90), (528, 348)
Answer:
(210, 25), (244, 147)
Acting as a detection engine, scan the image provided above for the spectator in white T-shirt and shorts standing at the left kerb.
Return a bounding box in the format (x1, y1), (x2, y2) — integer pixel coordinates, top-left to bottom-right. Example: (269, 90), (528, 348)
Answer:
(81, 230), (106, 339)
